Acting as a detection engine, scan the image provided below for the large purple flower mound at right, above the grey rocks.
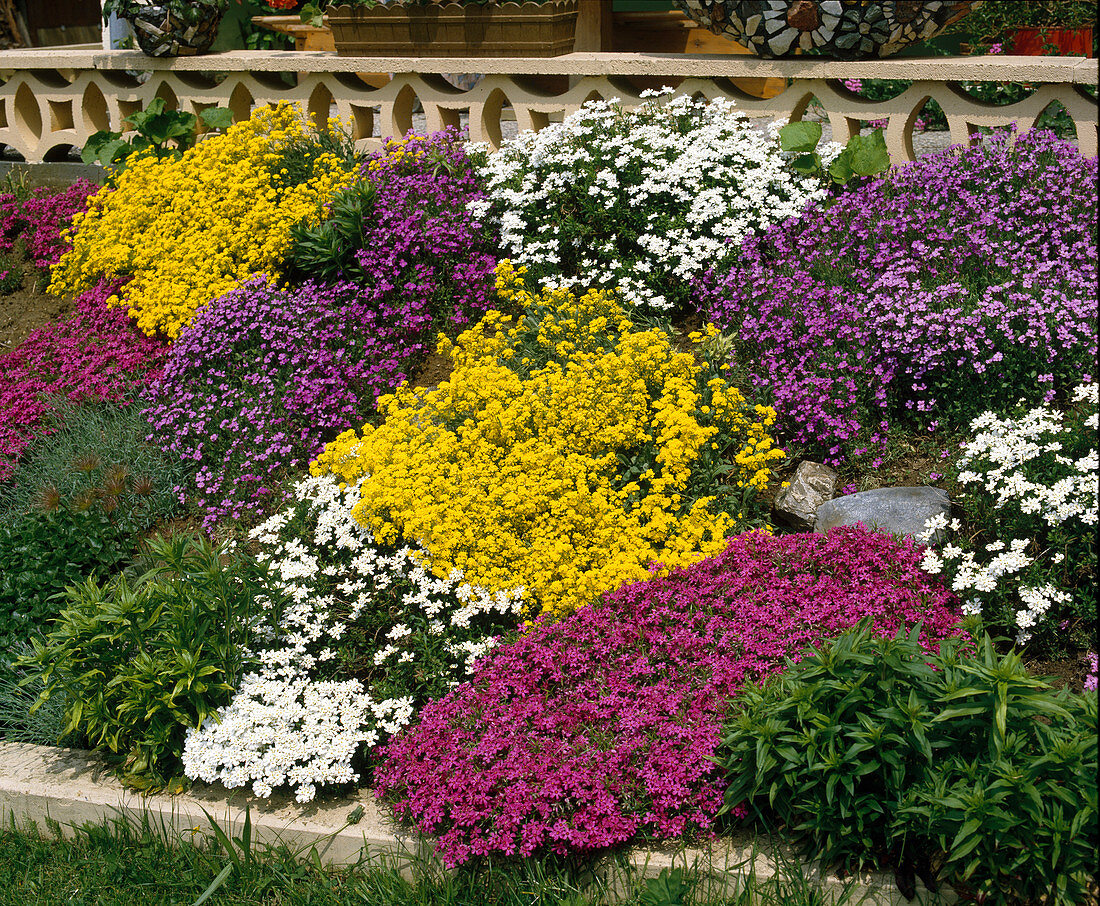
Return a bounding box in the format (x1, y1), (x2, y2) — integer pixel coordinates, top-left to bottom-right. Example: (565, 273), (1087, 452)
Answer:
(697, 131), (1097, 466)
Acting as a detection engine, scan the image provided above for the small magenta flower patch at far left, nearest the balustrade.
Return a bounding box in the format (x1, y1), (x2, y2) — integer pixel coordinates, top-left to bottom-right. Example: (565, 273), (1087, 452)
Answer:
(0, 179), (99, 268)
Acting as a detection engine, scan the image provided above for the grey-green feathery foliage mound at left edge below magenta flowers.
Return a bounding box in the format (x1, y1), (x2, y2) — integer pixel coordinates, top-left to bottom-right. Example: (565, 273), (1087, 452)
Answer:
(0, 400), (184, 533)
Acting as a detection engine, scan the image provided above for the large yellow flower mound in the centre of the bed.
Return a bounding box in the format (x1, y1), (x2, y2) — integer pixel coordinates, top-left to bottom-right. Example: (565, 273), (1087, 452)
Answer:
(312, 262), (783, 618)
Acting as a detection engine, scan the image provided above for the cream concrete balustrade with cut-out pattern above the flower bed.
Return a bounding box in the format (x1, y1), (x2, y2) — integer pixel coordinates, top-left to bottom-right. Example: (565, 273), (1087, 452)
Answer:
(0, 48), (1097, 162)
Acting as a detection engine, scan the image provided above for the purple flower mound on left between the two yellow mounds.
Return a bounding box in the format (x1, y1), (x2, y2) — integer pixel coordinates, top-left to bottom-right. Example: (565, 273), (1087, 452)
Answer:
(145, 277), (426, 529)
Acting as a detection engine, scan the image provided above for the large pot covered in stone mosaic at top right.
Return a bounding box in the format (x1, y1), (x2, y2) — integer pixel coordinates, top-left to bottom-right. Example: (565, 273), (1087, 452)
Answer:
(672, 0), (982, 59)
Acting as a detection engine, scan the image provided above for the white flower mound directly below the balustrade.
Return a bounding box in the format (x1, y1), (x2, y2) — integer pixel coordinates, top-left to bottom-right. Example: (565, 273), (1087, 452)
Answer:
(471, 89), (840, 311)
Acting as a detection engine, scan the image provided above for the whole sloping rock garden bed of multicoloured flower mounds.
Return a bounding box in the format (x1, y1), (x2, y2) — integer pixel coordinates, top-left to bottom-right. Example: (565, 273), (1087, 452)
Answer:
(0, 92), (1100, 906)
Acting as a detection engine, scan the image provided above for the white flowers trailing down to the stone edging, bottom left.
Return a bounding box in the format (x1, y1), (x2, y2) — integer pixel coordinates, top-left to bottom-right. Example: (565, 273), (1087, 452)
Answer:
(184, 476), (523, 802)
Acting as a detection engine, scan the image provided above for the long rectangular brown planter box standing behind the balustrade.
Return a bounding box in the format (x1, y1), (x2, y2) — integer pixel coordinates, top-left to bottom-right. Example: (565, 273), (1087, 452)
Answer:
(326, 0), (579, 57)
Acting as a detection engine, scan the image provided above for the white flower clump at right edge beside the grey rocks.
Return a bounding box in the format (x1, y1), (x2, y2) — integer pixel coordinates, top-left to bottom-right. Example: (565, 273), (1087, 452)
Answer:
(917, 384), (1100, 644)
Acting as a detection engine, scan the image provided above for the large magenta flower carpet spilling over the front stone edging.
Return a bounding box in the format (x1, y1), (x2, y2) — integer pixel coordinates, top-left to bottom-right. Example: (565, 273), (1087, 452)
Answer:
(375, 527), (958, 864)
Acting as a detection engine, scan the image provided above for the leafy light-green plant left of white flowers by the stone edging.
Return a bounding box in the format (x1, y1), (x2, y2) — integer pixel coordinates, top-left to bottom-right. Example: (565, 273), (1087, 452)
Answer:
(21, 537), (265, 787)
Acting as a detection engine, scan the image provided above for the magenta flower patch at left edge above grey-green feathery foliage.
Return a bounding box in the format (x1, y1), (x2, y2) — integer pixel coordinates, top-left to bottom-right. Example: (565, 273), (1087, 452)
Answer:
(0, 280), (166, 480)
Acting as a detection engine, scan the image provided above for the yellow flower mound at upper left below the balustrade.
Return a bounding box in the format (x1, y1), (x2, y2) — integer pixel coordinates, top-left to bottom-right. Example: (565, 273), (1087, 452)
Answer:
(50, 103), (353, 340)
